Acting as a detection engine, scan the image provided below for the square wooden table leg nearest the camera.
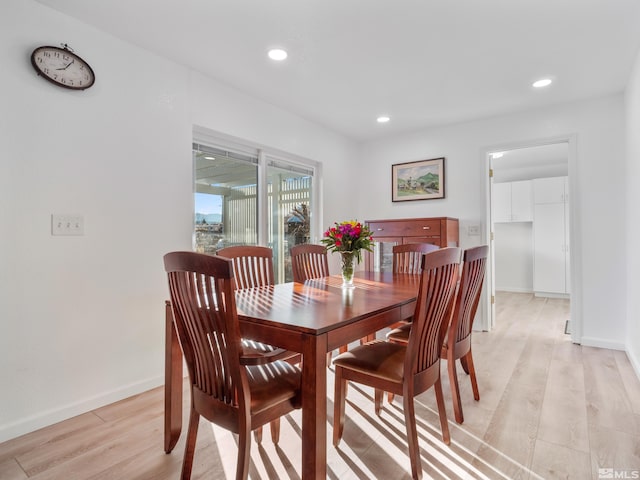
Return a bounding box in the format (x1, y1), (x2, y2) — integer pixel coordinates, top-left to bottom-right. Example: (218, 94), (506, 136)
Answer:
(302, 335), (327, 480)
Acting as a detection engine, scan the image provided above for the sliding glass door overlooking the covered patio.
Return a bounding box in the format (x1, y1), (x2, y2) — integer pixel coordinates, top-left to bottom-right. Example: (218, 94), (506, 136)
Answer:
(193, 137), (315, 283)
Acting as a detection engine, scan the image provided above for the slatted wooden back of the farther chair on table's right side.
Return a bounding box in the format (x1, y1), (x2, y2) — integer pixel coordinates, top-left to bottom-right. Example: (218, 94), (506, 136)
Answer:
(451, 245), (489, 342)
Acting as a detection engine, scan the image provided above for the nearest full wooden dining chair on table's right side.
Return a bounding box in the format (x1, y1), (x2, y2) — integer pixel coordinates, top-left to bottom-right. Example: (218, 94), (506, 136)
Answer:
(333, 247), (460, 478)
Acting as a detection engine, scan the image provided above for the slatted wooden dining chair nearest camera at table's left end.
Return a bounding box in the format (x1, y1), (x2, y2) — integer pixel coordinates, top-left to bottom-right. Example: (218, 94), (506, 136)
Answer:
(164, 252), (301, 480)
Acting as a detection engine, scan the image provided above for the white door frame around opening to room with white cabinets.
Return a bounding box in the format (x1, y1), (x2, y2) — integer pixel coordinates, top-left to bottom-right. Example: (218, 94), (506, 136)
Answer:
(481, 133), (582, 344)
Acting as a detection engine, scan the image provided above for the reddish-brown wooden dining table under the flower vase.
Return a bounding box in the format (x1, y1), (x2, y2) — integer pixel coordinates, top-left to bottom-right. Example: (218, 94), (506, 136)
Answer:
(164, 272), (419, 480)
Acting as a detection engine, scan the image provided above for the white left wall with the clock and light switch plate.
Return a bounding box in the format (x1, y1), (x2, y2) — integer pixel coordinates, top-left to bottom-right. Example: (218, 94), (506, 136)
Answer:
(0, 0), (357, 441)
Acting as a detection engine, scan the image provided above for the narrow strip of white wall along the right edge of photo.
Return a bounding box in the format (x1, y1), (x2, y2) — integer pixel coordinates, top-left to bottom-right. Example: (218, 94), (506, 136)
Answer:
(623, 52), (640, 377)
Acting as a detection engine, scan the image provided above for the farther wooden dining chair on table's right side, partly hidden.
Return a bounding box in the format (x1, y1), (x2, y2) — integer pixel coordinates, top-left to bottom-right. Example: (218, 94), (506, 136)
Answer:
(387, 245), (489, 423)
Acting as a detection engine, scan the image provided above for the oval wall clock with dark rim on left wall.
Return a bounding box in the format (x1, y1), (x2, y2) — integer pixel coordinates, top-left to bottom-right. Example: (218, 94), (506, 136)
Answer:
(31, 47), (95, 90)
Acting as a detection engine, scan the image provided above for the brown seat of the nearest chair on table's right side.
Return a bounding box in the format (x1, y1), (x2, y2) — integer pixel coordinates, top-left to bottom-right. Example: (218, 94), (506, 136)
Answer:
(333, 340), (407, 383)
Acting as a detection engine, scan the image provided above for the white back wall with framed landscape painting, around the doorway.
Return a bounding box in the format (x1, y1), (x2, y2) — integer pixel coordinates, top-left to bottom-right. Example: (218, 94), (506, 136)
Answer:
(360, 95), (627, 349)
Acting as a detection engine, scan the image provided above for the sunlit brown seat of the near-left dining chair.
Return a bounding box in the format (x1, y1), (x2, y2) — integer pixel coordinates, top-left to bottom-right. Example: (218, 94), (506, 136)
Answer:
(246, 360), (302, 415)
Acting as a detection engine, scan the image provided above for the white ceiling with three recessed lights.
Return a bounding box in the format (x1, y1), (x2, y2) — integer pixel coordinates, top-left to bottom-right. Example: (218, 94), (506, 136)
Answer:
(33, 0), (640, 140)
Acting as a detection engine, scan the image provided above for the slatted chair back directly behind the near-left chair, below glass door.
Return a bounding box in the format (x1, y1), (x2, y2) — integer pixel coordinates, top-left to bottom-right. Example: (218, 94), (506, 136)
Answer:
(216, 245), (275, 290)
